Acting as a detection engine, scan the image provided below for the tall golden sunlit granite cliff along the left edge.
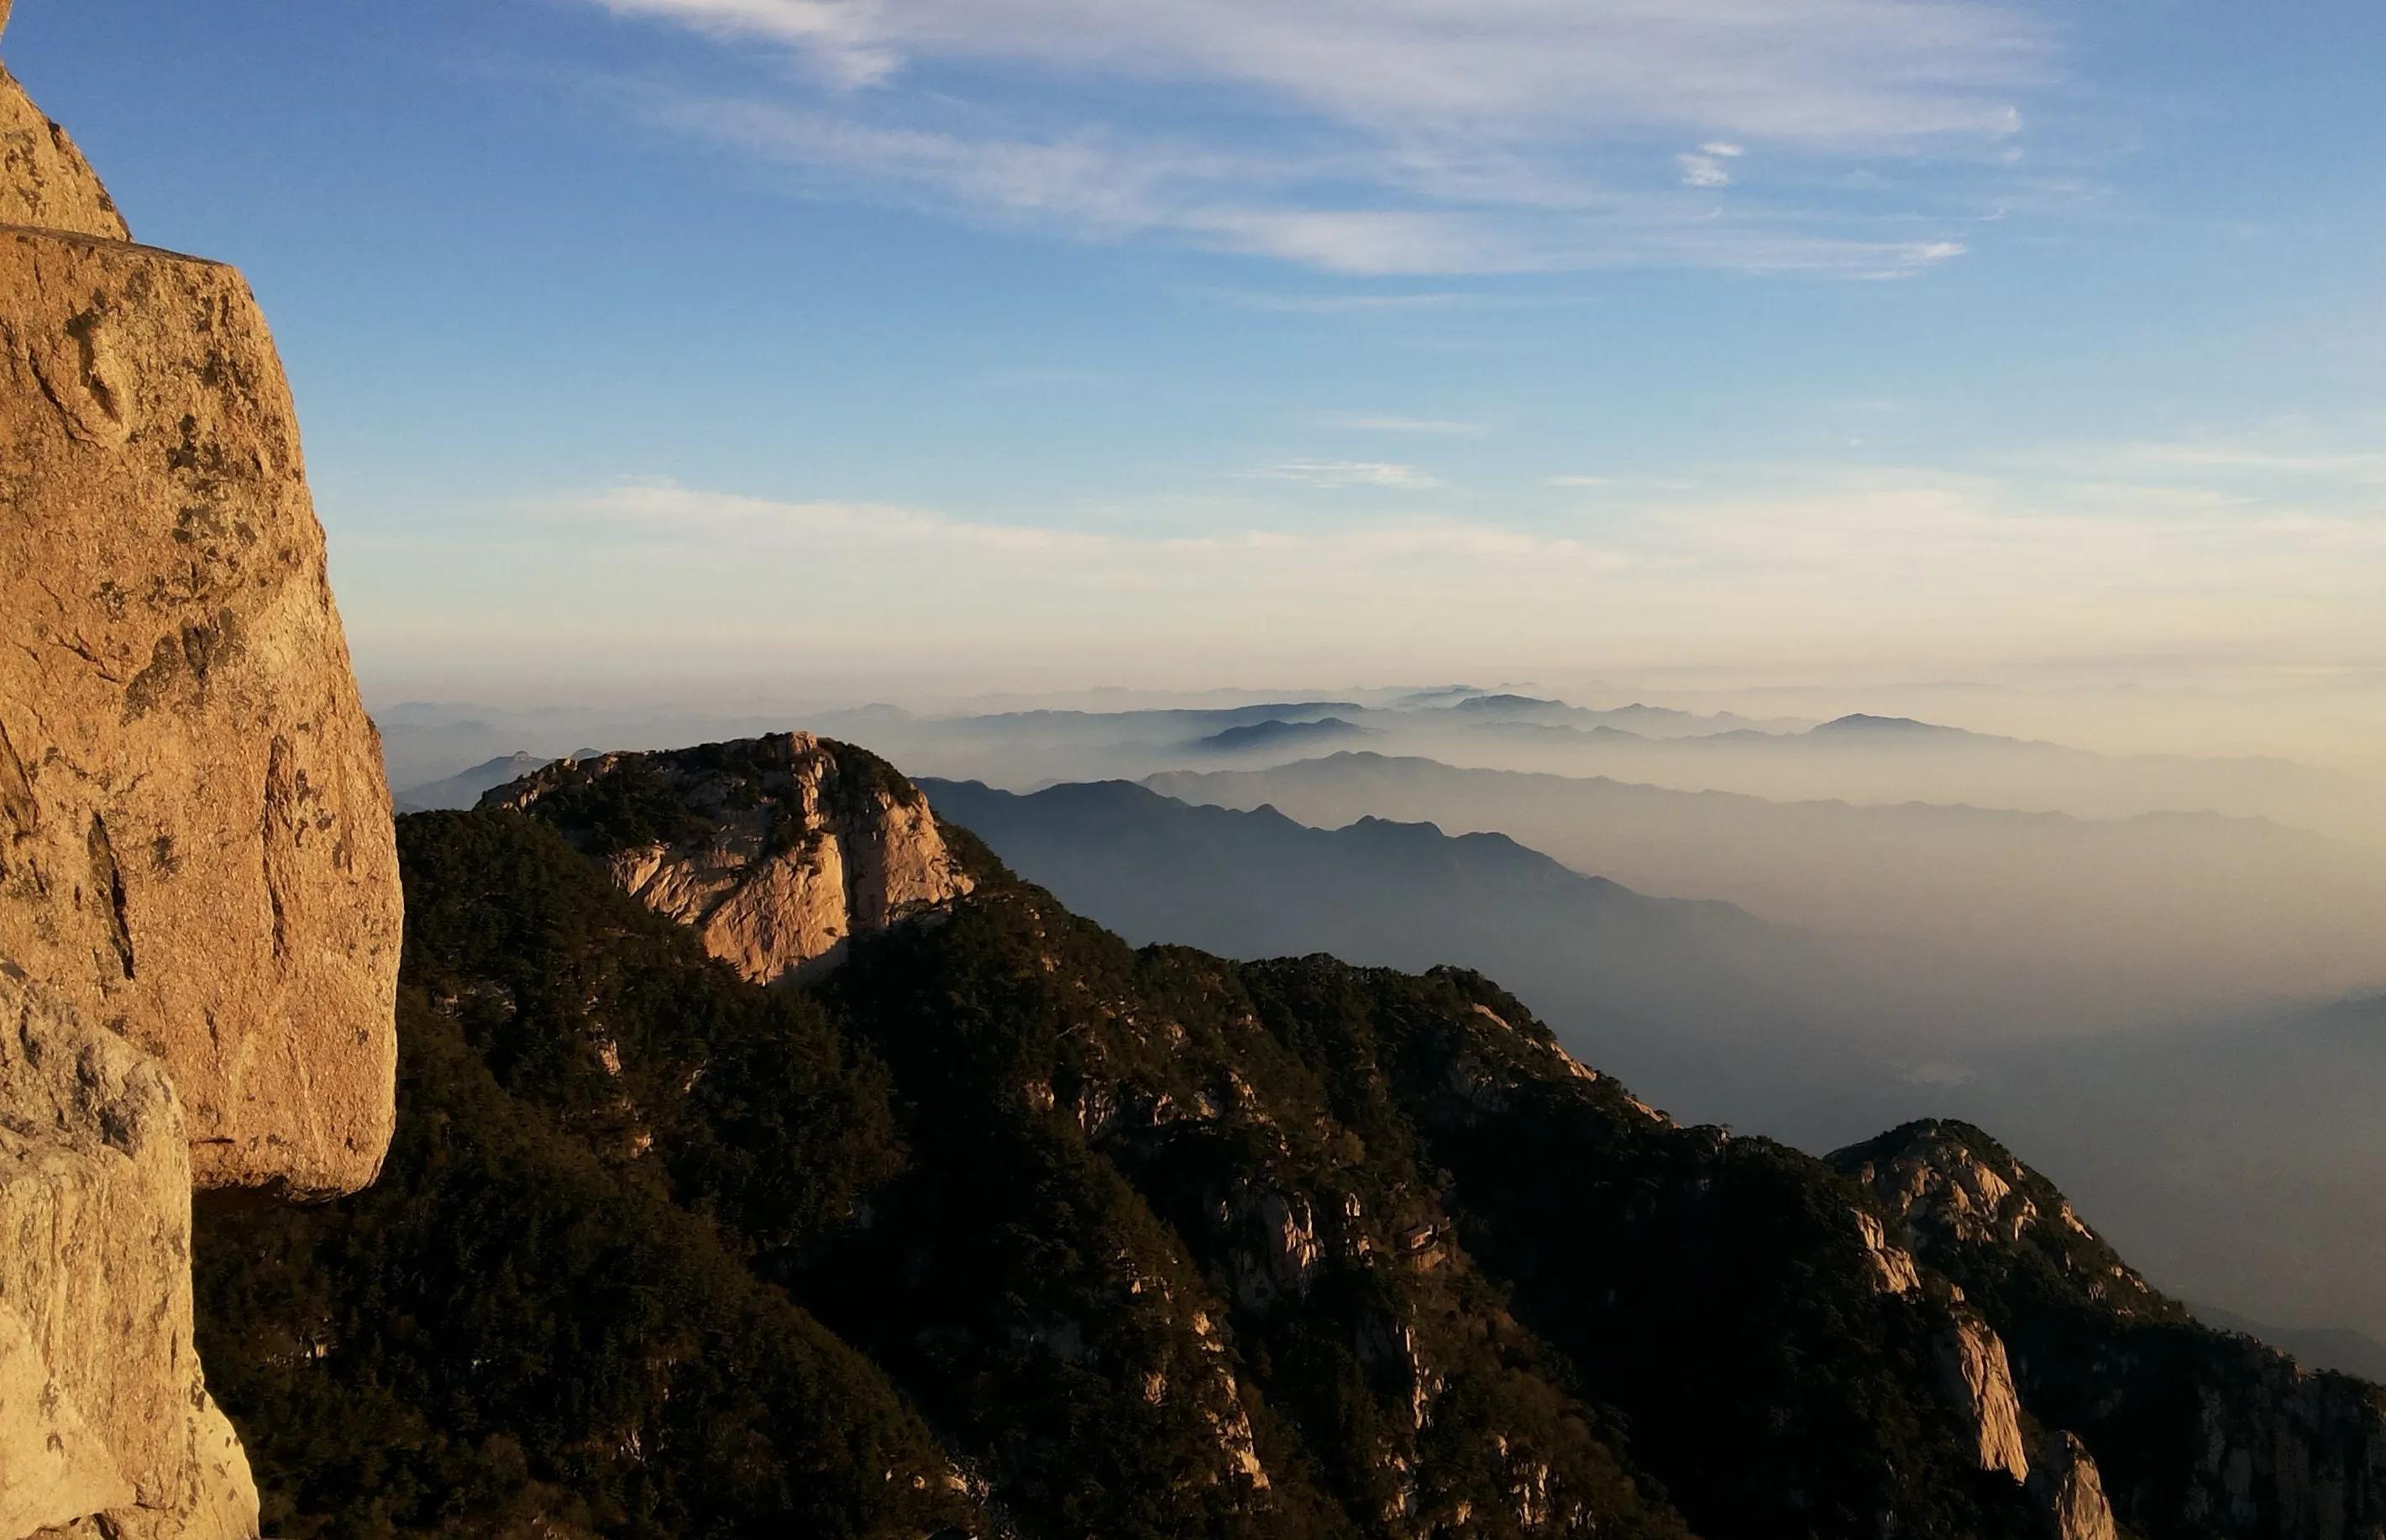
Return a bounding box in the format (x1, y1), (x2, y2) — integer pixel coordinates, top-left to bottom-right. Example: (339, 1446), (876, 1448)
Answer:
(0, 5), (398, 1537)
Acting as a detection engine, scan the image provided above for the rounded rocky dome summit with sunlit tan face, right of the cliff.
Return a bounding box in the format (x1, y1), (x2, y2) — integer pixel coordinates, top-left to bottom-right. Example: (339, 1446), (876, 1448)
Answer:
(482, 732), (971, 985)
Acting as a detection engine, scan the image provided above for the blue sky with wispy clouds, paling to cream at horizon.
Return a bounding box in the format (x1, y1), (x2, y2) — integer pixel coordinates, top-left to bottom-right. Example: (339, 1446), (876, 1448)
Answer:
(5, 0), (2386, 694)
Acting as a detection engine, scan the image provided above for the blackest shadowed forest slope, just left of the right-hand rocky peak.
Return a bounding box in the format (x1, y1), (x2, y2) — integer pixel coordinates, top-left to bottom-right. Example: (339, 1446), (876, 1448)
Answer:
(1248, 958), (2033, 1540)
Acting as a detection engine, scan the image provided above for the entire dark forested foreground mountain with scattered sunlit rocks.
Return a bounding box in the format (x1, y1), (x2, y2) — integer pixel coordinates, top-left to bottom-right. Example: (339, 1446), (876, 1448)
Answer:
(196, 739), (2386, 1540)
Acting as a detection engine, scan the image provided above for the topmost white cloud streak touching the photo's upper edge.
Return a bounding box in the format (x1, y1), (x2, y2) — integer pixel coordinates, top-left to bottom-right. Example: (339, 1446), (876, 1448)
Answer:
(599, 0), (2054, 148)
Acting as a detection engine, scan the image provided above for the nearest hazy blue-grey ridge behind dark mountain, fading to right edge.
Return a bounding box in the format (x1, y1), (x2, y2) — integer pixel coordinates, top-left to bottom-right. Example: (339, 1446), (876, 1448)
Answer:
(923, 782), (2386, 1369)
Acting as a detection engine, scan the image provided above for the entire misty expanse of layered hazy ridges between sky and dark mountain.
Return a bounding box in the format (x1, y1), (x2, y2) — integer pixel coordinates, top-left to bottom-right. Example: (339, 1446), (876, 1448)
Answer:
(372, 689), (2386, 1370)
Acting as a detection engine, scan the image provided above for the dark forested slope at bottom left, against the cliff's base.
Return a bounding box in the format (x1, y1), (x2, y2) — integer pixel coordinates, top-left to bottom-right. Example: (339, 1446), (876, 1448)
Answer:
(196, 987), (971, 1535)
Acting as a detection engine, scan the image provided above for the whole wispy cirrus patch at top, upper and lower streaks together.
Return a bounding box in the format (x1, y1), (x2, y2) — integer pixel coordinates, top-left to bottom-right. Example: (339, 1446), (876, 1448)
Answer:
(585, 0), (2063, 276)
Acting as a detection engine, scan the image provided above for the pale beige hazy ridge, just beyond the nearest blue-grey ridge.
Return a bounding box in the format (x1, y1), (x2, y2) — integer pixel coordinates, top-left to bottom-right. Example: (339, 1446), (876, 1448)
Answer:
(1148, 753), (2386, 1029)
